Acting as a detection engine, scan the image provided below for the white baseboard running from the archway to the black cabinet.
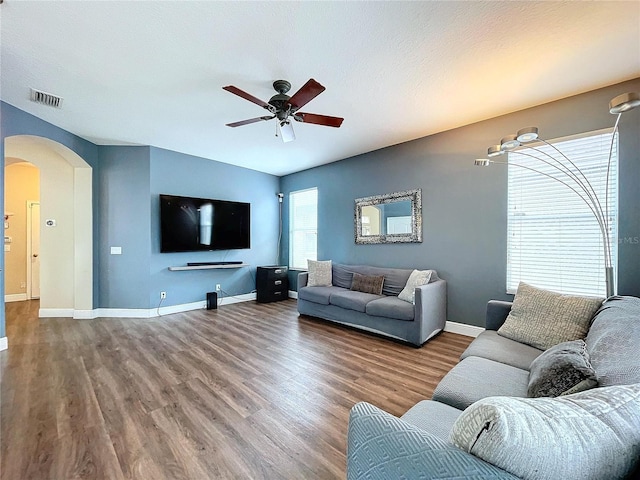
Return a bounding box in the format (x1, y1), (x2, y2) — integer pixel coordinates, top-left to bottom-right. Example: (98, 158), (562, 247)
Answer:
(38, 293), (256, 320)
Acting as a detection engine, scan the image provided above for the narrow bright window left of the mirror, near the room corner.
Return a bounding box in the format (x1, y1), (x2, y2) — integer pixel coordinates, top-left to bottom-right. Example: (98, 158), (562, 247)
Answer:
(289, 188), (318, 270)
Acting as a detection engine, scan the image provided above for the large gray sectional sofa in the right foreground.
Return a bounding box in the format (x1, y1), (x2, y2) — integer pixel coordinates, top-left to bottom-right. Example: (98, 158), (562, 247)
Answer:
(347, 297), (640, 480)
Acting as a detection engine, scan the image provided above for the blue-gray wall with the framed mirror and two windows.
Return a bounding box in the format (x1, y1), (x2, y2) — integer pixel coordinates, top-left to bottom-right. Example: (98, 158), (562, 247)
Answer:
(281, 79), (640, 326)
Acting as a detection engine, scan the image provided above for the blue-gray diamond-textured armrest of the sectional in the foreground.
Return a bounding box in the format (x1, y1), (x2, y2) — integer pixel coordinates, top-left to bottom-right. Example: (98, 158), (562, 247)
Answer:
(347, 402), (516, 480)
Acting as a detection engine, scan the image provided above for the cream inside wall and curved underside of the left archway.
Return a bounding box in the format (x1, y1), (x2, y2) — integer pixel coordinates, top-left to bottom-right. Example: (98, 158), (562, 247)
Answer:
(4, 135), (94, 318)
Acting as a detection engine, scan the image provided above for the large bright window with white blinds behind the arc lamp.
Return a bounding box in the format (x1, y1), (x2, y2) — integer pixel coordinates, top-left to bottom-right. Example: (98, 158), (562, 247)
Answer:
(507, 130), (618, 296)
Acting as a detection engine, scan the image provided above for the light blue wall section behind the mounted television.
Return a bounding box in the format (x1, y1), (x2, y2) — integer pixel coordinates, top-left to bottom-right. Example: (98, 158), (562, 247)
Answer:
(147, 147), (280, 306)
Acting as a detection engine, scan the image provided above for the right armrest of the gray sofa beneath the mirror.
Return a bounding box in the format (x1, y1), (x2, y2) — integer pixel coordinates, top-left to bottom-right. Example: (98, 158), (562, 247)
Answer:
(413, 279), (447, 345)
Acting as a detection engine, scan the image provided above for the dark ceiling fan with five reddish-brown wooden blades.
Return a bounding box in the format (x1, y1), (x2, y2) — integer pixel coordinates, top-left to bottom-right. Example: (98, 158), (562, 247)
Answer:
(222, 78), (344, 142)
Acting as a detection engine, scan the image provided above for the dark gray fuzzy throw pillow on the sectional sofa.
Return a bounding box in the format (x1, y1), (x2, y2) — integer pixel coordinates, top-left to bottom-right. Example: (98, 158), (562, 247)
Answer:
(527, 340), (598, 397)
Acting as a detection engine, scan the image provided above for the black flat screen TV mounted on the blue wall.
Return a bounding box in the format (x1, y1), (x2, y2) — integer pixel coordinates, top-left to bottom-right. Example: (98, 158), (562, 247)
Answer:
(160, 195), (251, 253)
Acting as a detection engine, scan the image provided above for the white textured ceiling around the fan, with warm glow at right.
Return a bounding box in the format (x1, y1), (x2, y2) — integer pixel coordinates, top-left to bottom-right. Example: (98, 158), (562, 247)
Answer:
(0, 0), (640, 175)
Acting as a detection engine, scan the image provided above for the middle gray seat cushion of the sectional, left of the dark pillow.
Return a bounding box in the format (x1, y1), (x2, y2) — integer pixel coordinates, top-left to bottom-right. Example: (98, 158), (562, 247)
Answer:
(432, 357), (529, 410)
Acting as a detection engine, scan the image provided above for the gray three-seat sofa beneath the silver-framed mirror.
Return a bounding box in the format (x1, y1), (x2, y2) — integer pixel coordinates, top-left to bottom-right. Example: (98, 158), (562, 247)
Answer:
(298, 264), (447, 347)
